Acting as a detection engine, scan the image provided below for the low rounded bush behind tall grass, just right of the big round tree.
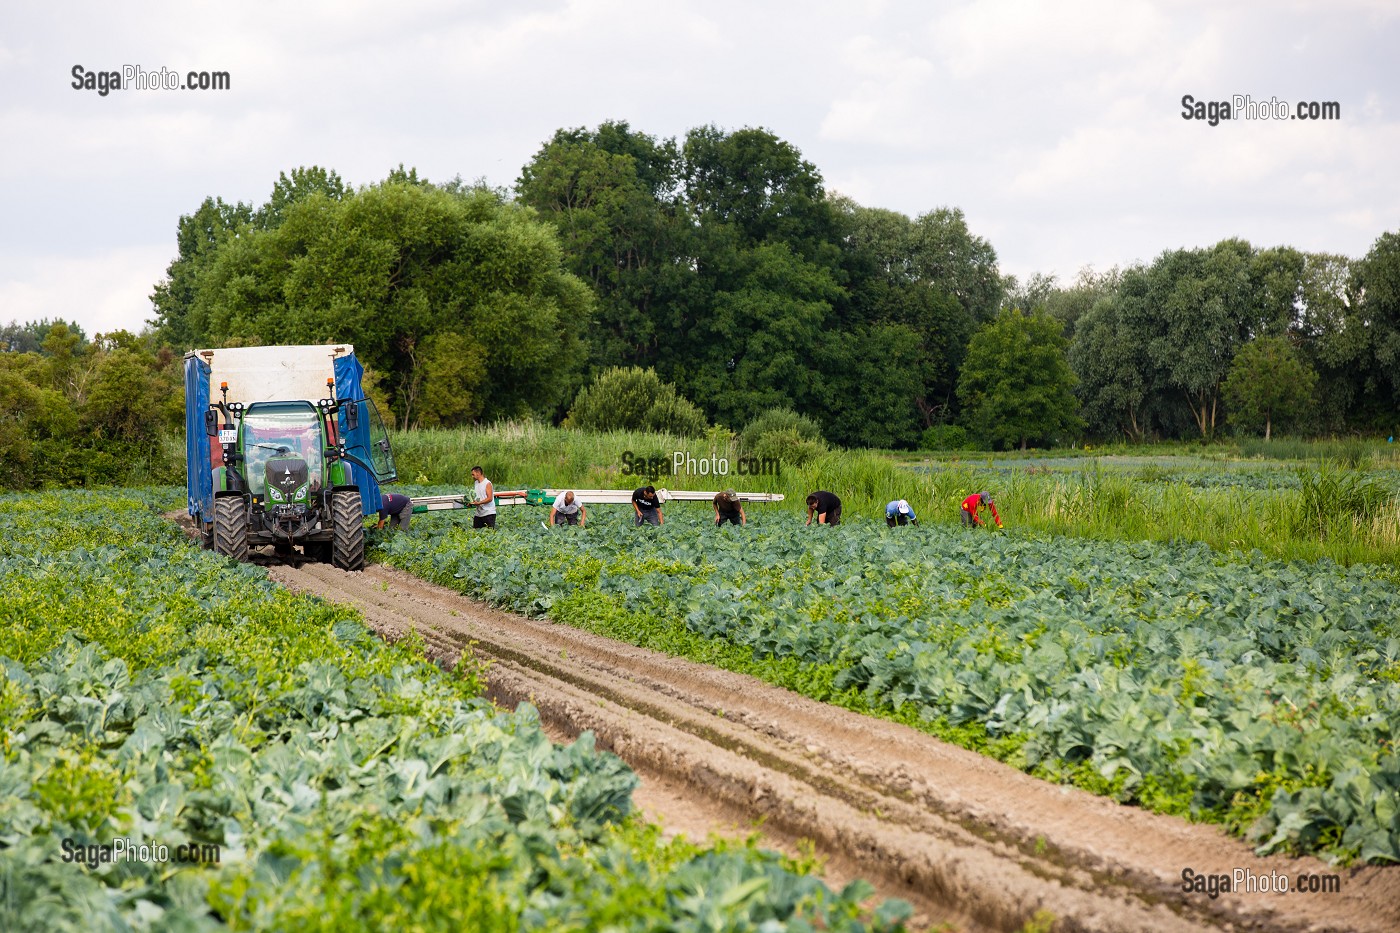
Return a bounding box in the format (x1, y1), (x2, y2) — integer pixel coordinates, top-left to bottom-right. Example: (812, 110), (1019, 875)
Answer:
(564, 366), (710, 437)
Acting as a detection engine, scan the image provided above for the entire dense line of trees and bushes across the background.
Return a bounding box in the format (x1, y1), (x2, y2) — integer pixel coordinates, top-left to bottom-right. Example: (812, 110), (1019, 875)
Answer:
(0, 123), (1400, 486)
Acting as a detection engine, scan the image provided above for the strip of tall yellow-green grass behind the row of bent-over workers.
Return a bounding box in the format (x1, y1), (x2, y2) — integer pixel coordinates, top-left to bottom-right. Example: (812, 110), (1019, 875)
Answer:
(393, 424), (1400, 566)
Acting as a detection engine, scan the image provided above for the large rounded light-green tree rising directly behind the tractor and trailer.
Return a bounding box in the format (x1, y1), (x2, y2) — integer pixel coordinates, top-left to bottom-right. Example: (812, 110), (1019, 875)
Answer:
(186, 179), (594, 426)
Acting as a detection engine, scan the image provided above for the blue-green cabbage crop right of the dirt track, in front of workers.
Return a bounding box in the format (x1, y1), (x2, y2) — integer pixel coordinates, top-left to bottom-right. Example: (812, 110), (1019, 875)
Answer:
(381, 504), (1400, 862)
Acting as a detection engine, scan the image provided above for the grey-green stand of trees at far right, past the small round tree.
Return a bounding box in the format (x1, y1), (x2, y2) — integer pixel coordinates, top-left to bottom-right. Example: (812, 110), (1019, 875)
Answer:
(1058, 234), (1400, 440)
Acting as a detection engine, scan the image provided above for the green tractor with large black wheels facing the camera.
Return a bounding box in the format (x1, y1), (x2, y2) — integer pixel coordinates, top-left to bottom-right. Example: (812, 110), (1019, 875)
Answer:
(203, 382), (396, 570)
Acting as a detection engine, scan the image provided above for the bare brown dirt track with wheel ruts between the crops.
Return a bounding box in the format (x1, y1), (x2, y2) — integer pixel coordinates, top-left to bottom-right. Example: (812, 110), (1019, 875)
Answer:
(260, 551), (1400, 933)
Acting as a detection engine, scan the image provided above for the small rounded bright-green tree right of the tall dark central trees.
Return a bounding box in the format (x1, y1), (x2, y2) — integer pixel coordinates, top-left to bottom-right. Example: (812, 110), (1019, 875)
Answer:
(958, 308), (1082, 450)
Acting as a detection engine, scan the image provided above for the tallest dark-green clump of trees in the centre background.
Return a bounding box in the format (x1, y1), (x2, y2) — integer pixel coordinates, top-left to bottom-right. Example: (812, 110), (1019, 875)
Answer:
(518, 123), (1001, 447)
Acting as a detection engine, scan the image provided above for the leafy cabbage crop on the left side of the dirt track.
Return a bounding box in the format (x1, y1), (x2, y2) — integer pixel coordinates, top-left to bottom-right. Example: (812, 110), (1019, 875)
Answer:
(0, 489), (909, 932)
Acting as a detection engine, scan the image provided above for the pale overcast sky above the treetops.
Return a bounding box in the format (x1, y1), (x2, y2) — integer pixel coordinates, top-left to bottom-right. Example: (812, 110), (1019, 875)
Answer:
(0, 0), (1400, 335)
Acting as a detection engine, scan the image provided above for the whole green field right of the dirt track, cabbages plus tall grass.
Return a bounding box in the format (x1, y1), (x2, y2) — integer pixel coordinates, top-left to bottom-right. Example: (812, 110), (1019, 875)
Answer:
(375, 426), (1400, 862)
